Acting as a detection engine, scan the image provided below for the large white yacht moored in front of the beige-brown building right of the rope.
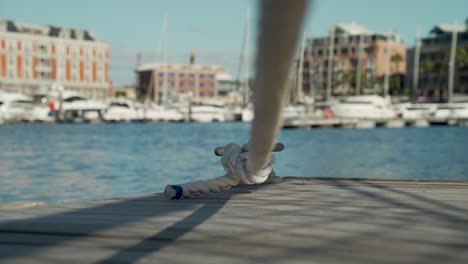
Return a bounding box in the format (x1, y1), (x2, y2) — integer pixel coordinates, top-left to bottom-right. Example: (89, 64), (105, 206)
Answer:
(331, 95), (397, 119)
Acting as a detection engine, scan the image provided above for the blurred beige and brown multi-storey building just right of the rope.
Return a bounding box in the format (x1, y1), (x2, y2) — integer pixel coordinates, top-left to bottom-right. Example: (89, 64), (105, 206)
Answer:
(302, 23), (406, 98)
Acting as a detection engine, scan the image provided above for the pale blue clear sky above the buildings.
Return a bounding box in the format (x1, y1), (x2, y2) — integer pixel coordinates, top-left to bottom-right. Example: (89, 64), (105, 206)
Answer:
(0, 0), (468, 86)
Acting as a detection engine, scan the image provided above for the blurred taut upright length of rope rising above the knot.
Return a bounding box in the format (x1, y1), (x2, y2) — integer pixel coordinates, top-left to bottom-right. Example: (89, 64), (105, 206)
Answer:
(247, 0), (308, 172)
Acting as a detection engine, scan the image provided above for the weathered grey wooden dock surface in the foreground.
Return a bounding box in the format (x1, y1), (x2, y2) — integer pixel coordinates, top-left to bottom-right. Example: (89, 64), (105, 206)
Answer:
(0, 177), (468, 264)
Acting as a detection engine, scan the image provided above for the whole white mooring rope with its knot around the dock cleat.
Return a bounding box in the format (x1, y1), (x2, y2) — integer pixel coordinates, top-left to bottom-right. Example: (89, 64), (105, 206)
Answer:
(164, 0), (308, 199)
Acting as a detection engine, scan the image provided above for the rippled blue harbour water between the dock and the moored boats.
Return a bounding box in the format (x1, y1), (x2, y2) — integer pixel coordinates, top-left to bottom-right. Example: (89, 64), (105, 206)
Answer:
(0, 123), (468, 204)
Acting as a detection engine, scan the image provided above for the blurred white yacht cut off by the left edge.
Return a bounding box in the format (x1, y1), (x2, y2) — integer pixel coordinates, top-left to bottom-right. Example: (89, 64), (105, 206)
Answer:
(0, 92), (32, 123)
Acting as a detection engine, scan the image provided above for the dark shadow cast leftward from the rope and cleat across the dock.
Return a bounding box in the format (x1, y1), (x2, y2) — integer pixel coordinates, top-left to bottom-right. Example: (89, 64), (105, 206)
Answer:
(0, 190), (231, 263)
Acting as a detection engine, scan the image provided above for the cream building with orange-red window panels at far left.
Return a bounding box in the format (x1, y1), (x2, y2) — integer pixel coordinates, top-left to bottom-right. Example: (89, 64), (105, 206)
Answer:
(0, 20), (110, 98)
